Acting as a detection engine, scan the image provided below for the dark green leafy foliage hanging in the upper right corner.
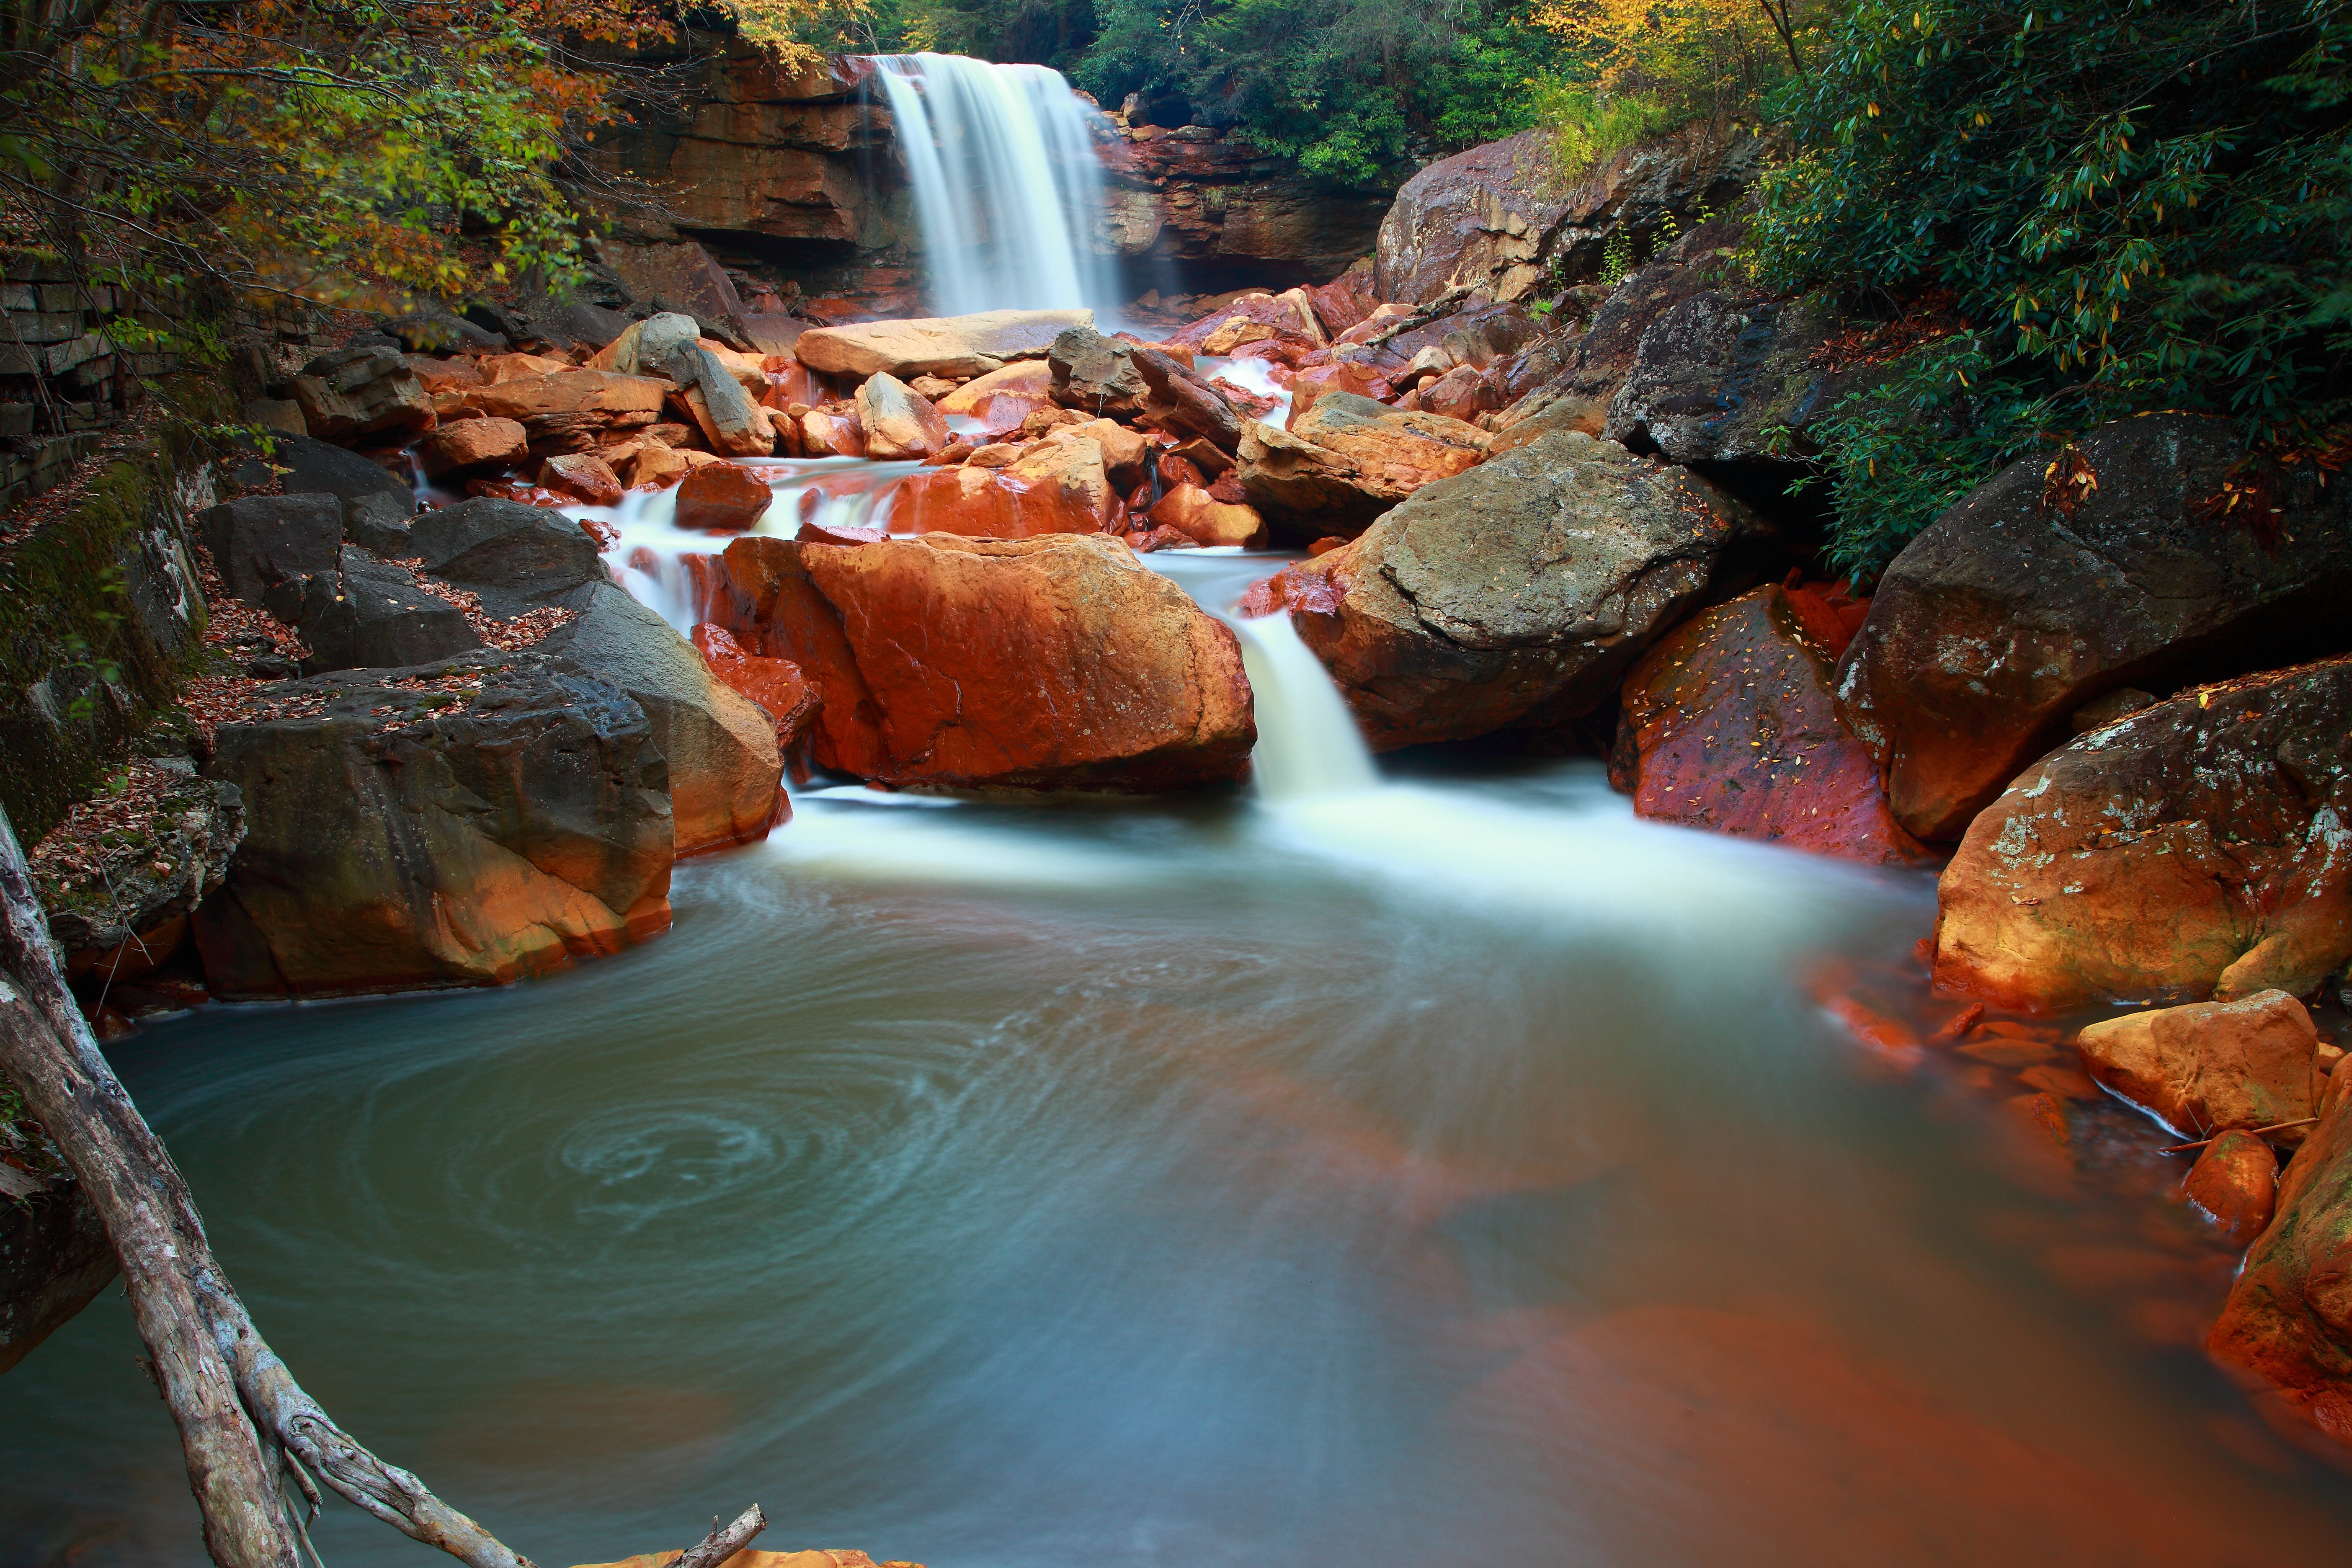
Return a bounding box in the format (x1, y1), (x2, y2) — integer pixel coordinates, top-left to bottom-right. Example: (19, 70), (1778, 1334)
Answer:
(1750, 0), (2352, 580)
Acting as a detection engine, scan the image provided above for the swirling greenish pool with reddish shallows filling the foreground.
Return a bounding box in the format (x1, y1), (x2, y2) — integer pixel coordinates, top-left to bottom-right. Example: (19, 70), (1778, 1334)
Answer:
(0, 762), (2352, 1568)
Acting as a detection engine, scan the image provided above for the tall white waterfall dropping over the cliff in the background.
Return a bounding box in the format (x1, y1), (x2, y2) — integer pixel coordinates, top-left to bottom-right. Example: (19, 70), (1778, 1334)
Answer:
(875, 54), (1119, 315)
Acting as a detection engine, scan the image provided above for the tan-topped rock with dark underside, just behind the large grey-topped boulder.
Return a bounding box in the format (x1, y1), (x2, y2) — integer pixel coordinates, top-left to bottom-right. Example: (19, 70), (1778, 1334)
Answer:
(1240, 392), (1486, 538)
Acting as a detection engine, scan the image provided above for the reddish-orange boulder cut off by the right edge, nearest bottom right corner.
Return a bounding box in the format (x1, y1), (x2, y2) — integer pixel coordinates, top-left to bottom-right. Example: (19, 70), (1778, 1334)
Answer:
(2206, 1096), (2352, 1441)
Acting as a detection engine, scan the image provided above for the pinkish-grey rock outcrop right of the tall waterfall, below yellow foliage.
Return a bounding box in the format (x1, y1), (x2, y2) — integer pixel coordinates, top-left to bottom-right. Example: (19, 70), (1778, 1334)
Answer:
(1376, 127), (1767, 306)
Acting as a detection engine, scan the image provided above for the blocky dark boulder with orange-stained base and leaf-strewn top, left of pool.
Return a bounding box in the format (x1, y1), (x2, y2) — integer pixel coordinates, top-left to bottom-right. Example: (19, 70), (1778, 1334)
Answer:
(195, 651), (673, 999)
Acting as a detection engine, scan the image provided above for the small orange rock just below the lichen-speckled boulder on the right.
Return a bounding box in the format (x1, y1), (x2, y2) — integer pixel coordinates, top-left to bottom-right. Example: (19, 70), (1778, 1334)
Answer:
(2074, 990), (2319, 1145)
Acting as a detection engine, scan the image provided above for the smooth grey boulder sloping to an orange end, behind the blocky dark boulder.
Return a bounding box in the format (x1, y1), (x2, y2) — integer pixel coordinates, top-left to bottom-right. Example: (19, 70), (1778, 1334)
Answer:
(416, 501), (783, 856)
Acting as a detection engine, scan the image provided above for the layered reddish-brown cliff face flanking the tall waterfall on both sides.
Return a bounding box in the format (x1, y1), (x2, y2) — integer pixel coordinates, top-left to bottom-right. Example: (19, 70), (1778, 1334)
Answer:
(597, 33), (1387, 296)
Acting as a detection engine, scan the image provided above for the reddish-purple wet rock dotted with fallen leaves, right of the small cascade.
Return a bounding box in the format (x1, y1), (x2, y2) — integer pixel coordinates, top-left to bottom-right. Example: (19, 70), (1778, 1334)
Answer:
(1611, 588), (1926, 865)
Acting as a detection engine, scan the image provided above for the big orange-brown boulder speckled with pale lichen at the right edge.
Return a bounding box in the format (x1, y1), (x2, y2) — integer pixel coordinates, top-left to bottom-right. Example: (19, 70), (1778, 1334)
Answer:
(1929, 653), (2352, 1008)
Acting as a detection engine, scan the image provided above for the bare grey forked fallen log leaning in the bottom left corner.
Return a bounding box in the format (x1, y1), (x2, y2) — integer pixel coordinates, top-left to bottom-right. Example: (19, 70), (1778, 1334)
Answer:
(0, 811), (748, 1568)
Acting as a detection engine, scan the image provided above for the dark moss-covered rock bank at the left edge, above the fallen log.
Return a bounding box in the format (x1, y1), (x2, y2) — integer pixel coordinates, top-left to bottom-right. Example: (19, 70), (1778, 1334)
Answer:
(0, 371), (233, 844)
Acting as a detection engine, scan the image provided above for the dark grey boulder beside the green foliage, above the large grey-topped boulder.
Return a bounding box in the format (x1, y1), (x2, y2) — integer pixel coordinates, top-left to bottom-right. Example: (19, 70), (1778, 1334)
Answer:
(1609, 289), (1858, 463)
